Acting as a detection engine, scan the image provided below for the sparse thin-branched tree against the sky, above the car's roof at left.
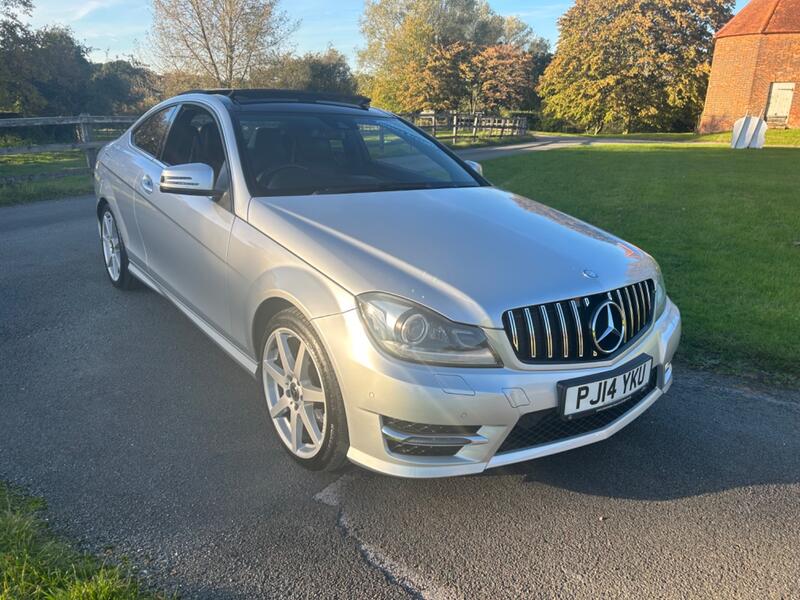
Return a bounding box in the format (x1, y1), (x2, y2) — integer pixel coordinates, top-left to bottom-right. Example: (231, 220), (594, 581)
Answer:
(149, 0), (297, 87)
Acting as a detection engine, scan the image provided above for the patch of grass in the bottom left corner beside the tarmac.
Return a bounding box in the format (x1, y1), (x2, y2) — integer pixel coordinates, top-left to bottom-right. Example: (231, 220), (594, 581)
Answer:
(0, 483), (164, 600)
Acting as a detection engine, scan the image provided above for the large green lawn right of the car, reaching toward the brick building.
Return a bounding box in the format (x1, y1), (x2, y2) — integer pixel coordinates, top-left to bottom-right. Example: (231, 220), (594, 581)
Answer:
(484, 144), (800, 383)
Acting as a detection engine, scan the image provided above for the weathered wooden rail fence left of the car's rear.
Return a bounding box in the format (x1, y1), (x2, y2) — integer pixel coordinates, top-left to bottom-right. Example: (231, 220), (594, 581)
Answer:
(0, 115), (138, 186)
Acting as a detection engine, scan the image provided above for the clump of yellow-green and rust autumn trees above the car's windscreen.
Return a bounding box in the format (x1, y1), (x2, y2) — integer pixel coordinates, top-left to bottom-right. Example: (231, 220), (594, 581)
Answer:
(359, 0), (549, 112)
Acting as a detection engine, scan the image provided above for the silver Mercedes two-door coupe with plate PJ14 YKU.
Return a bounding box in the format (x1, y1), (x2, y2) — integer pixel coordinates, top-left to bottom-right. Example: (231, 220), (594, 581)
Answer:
(95, 90), (681, 477)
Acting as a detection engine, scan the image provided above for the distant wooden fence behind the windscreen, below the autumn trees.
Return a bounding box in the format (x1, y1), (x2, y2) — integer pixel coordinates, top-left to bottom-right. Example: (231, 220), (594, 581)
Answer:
(403, 112), (528, 142)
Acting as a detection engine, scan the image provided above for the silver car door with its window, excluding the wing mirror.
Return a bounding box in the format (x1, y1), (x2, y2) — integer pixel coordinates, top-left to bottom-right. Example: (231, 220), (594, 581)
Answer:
(137, 104), (234, 334)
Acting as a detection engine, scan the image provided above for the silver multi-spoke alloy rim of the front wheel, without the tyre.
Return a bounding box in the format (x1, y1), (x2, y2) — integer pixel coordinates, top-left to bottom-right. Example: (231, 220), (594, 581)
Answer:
(262, 327), (328, 459)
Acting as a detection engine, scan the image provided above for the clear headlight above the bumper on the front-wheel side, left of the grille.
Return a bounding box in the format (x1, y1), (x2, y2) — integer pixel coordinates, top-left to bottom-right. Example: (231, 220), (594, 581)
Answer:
(358, 292), (500, 367)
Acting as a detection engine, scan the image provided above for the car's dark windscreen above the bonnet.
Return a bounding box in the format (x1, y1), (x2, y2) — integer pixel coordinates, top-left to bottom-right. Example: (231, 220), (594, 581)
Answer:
(231, 112), (481, 196)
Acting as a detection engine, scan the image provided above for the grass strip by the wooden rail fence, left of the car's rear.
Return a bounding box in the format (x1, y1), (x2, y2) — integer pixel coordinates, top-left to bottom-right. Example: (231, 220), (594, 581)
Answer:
(0, 152), (92, 206)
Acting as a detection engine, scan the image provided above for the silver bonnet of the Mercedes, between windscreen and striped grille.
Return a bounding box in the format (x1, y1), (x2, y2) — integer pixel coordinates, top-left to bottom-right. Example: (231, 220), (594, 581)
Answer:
(248, 187), (657, 328)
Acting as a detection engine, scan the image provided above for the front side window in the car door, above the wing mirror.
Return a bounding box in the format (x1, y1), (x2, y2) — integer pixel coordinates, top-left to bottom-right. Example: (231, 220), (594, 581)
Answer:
(161, 104), (225, 178)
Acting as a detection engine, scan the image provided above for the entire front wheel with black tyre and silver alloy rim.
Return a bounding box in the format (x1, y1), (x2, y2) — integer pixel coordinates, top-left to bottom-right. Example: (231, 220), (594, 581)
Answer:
(260, 308), (350, 471)
